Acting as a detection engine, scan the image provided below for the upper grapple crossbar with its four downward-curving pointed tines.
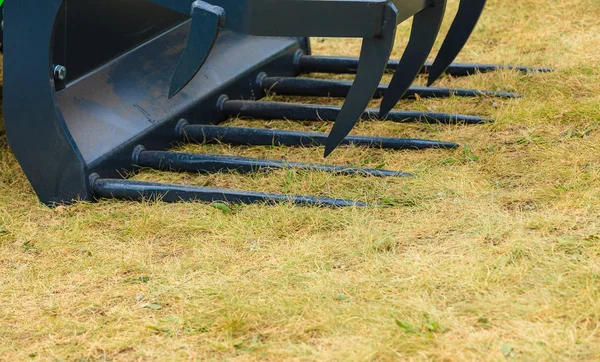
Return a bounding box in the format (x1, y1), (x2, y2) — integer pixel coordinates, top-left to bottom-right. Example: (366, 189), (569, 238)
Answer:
(152, 0), (540, 156)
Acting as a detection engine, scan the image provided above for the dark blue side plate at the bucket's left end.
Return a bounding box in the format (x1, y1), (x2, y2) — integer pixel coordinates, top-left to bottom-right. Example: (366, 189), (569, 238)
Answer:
(3, 0), (91, 203)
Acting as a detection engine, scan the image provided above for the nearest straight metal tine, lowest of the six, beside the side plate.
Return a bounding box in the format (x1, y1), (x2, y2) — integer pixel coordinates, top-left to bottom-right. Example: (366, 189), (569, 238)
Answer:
(92, 175), (369, 207)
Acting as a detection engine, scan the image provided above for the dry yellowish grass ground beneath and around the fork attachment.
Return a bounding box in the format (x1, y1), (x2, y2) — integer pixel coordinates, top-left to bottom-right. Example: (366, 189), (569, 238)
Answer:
(0, 0), (600, 361)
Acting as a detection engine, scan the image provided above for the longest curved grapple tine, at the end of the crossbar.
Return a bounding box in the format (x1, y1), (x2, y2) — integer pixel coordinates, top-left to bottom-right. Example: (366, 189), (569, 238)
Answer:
(325, 3), (398, 157)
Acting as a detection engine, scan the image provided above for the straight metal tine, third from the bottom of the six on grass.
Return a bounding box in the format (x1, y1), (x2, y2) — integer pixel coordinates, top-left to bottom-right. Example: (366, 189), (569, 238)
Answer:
(177, 120), (458, 150)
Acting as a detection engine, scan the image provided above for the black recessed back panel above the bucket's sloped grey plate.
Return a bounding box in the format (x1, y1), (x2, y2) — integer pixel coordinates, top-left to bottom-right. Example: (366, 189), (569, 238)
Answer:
(52, 0), (186, 83)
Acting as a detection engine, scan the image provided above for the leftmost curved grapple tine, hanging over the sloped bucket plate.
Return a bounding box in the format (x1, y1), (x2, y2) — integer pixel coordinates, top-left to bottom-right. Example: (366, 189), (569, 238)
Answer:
(169, 1), (225, 99)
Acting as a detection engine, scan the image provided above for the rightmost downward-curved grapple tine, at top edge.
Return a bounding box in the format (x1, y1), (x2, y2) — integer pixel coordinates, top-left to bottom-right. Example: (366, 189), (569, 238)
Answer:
(427, 0), (486, 86)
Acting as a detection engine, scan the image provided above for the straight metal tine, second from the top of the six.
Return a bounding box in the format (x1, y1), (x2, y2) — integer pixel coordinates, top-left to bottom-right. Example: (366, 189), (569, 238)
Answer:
(261, 77), (523, 98)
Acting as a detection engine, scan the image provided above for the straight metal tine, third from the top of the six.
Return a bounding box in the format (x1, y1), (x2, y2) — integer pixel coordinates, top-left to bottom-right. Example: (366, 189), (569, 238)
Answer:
(221, 100), (494, 124)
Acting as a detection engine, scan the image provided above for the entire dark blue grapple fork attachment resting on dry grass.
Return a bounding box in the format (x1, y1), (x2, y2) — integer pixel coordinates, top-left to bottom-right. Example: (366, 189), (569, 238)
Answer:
(2, 0), (552, 206)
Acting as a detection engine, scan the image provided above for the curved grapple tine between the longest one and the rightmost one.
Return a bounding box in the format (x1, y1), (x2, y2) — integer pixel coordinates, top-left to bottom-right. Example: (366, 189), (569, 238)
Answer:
(379, 0), (447, 118)
